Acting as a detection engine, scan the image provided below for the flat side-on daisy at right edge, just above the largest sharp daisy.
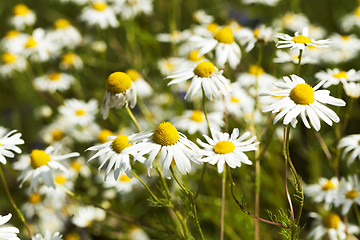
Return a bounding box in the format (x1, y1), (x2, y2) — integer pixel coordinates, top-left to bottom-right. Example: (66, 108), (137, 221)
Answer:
(315, 68), (360, 88)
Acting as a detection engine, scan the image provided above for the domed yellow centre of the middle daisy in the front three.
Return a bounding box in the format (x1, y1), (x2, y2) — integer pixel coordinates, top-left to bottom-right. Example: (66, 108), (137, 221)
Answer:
(153, 122), (179, 146)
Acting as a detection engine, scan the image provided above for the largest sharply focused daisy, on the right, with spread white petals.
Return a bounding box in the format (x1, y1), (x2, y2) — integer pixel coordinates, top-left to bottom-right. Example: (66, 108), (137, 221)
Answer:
(261, 74), (346, 131)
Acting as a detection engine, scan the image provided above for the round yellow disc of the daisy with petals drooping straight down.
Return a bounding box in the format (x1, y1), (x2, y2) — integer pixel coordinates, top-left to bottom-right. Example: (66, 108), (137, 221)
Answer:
(106, 72), (131, 94)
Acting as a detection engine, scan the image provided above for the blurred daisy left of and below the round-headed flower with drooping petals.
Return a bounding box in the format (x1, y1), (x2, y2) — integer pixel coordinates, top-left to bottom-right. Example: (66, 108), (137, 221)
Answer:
(59, 99), (98, 126)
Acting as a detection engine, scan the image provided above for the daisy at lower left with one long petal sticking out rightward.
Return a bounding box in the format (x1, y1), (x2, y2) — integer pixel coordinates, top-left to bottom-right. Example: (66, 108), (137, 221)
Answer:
(18, 146), (80, 190)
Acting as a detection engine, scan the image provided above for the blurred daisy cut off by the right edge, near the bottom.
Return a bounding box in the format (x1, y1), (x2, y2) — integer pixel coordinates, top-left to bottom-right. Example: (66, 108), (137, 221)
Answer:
(334, 175), (360, 215)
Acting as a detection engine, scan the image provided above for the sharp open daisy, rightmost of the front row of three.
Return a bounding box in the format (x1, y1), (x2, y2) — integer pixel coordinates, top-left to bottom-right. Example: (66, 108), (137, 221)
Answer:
(197, 128), (260, 173)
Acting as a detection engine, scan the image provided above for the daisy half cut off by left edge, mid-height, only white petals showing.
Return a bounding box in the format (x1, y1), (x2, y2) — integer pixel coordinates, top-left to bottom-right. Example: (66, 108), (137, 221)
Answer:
(0, 127), (24, 164)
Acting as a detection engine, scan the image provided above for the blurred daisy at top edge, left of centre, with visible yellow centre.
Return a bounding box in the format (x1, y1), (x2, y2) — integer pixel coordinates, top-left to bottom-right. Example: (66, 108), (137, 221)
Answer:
(80, 0), (120, 29)
